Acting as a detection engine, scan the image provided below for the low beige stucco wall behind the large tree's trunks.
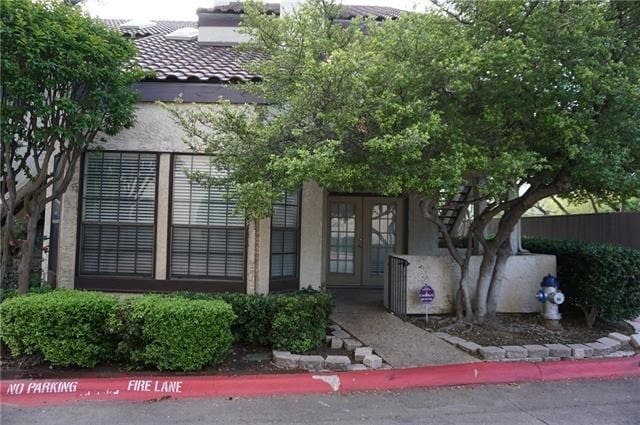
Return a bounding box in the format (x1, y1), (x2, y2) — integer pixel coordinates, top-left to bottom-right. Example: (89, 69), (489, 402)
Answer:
(385, 254), (556, 314)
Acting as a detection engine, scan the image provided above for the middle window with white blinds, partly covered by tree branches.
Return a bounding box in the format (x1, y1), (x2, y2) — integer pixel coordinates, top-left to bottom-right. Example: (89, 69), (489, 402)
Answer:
(170, 155), (245, 280)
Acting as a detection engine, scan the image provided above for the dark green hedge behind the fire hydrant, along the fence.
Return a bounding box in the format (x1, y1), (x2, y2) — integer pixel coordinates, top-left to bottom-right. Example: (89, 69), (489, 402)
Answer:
(523, 238), (640, 326)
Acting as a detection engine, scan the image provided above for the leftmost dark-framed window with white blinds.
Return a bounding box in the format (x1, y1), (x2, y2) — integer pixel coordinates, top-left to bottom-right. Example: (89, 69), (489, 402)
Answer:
(80, 152), (157, 277)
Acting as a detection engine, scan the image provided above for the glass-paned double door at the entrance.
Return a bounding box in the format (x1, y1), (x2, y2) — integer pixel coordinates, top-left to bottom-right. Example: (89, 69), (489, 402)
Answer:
(326, 196), (404, 286)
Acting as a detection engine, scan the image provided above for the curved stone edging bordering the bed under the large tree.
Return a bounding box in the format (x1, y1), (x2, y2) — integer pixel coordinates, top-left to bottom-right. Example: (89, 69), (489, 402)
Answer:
(432, 332), (640, 362)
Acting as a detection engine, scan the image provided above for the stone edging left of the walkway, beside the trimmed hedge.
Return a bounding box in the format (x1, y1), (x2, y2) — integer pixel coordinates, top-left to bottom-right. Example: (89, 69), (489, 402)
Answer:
(273, 325), (391, 372)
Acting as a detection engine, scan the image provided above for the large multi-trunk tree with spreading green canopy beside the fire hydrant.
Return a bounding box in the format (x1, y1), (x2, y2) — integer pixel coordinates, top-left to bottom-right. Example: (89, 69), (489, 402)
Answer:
(170, 0), (640, 321)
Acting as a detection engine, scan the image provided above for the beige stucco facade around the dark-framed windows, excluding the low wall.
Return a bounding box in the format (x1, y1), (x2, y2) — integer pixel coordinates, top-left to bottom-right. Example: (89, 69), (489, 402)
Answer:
(43, 103), (316, 293)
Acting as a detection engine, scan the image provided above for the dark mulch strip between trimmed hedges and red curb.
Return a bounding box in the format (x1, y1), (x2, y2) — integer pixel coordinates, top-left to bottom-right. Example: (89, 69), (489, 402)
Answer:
(0, 345), (353, 379)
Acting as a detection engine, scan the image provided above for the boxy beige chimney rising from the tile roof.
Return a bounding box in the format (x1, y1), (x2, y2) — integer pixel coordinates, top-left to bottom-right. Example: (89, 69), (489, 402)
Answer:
(196, 0), (249, 46)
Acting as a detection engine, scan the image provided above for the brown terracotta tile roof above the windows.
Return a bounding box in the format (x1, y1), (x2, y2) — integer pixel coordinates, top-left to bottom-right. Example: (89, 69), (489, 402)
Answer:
(103, 2), (402, 83)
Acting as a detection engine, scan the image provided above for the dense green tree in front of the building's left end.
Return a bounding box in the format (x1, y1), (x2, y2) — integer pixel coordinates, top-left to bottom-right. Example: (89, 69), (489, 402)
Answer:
(0, 0), (142, 293)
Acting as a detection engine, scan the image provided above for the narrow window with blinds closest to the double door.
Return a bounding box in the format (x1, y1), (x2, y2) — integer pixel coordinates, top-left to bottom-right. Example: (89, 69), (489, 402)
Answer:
(271, 191), (300, 280)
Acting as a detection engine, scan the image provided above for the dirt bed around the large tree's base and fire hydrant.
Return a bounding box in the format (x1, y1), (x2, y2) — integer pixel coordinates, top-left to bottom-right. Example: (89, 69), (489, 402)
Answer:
(409, 310), (633, 346)
